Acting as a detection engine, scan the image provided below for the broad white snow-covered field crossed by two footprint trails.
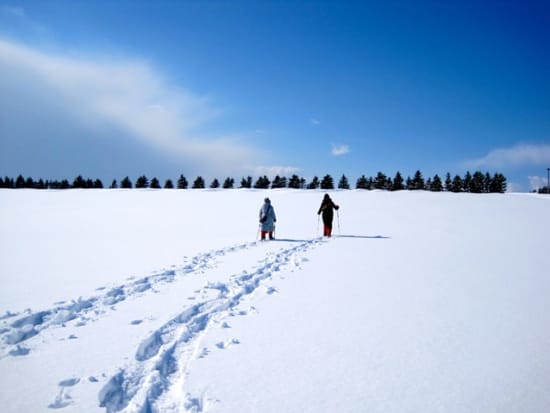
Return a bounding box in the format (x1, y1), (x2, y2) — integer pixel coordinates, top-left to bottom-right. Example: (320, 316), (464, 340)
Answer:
(0, 189), (550, 413)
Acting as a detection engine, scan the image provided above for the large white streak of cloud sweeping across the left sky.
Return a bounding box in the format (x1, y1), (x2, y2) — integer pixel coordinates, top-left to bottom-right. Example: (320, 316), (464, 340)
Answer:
(0, 39), (257, 175)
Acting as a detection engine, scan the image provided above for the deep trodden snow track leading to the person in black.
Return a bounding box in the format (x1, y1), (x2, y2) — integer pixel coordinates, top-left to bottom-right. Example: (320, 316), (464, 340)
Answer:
(99, 239), (321, 412)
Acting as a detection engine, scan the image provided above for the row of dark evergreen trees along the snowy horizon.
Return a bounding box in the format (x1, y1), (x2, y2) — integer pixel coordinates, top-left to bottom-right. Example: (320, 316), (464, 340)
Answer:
(0, 171), (507, 193)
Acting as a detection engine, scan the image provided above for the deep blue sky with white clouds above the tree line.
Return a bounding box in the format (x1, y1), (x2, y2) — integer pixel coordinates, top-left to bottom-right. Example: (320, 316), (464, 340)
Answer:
(0, 0), (550, 191)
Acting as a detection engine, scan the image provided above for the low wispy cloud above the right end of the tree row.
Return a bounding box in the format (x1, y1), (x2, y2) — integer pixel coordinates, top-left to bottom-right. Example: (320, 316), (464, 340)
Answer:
(464, 144), (550, 168)
